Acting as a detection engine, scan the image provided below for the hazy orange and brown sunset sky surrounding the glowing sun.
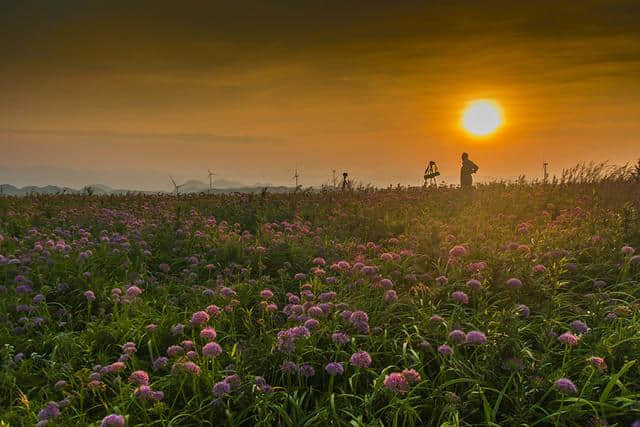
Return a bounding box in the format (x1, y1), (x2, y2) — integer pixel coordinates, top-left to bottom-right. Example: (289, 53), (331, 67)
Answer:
(0, 0), (640, 189)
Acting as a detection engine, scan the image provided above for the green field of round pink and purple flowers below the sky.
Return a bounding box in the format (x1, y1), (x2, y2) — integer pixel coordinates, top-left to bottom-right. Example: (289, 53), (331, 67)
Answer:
(0, 176), (640, 426)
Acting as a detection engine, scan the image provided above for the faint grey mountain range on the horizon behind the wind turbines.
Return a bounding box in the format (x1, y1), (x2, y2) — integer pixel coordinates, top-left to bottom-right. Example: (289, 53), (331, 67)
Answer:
(0, 179), (293, 196)
